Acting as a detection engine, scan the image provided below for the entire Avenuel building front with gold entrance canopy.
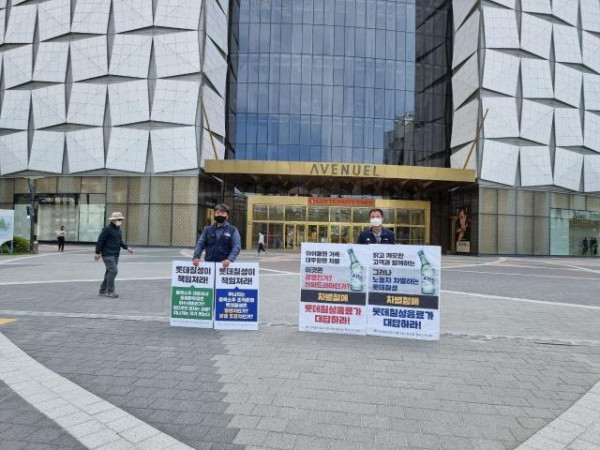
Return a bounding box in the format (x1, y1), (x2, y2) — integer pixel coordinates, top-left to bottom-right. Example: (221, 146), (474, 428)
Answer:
(0, 0), (600, 255)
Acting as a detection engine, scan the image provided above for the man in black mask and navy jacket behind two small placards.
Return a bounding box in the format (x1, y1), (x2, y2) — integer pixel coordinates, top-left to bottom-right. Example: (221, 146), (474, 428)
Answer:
(192, 204), (242, 268)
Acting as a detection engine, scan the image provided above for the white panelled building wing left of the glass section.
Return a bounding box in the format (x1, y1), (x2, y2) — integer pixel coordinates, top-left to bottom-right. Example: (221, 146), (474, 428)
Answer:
(0, 0), (229, 245)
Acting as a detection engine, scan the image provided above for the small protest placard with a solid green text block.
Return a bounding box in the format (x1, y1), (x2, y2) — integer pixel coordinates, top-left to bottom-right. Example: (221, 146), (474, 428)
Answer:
(171, 261), (215, 328)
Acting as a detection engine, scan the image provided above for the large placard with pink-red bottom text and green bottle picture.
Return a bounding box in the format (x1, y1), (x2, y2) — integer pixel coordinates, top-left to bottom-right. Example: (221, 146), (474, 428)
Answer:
(300, 243), (369, 335)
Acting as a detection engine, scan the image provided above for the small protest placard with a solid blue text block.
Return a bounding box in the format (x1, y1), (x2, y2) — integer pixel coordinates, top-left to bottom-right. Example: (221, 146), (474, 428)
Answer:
(215, 263), (258, 330)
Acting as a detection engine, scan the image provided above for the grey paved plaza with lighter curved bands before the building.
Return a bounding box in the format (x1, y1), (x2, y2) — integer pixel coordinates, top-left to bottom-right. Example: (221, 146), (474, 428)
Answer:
(0, 246), (600, 450)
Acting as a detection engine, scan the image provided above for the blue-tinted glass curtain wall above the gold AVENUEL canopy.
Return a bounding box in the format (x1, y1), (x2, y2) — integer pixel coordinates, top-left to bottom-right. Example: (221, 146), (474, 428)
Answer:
(227, 0), (451, 165)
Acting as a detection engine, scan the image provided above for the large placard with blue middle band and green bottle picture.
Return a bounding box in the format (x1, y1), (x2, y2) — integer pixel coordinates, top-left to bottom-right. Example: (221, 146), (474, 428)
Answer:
(367, 245), (441, 340)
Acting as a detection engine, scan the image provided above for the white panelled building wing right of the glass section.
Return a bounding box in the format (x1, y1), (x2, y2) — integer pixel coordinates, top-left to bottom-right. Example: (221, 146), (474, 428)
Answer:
(451, 0), (600, 255)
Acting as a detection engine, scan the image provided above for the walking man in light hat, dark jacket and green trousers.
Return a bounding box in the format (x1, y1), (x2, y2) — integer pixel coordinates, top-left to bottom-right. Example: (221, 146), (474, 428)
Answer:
(94, 212), (133, 298)
